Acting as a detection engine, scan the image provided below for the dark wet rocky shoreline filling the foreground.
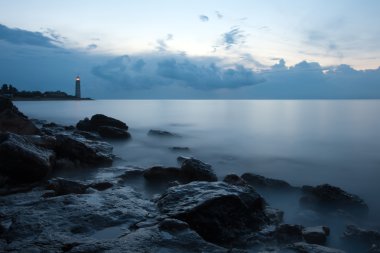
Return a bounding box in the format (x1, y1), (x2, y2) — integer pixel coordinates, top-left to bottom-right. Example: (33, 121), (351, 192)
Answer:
(0, 98), (380, 253)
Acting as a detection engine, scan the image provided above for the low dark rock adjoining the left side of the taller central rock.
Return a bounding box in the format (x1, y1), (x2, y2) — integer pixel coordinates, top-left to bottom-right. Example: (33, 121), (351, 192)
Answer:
(144, 166), (182, 181)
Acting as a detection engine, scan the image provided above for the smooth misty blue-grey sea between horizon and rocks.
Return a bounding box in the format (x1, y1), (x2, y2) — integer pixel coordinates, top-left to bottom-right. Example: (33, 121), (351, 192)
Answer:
(16, 100), (380, 248)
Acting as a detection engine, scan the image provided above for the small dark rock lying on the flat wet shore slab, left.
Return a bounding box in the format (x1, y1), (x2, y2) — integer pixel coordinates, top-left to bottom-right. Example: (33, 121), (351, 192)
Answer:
(46, 178), (88, 196)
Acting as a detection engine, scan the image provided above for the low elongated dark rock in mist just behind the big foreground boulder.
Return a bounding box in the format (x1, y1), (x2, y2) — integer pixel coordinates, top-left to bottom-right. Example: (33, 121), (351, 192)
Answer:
(241, 173), (294, 190)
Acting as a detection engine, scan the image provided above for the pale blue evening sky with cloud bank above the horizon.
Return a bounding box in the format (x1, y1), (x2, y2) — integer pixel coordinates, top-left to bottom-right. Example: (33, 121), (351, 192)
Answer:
(0, 0), (380, 99)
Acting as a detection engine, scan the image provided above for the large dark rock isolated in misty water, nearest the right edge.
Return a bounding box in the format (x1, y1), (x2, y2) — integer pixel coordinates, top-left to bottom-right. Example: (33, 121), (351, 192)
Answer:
(300, 184), (368, 215)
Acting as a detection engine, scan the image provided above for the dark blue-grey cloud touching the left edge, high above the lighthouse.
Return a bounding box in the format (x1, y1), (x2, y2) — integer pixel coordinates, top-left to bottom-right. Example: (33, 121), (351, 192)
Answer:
(0, 24), (57, 48)
